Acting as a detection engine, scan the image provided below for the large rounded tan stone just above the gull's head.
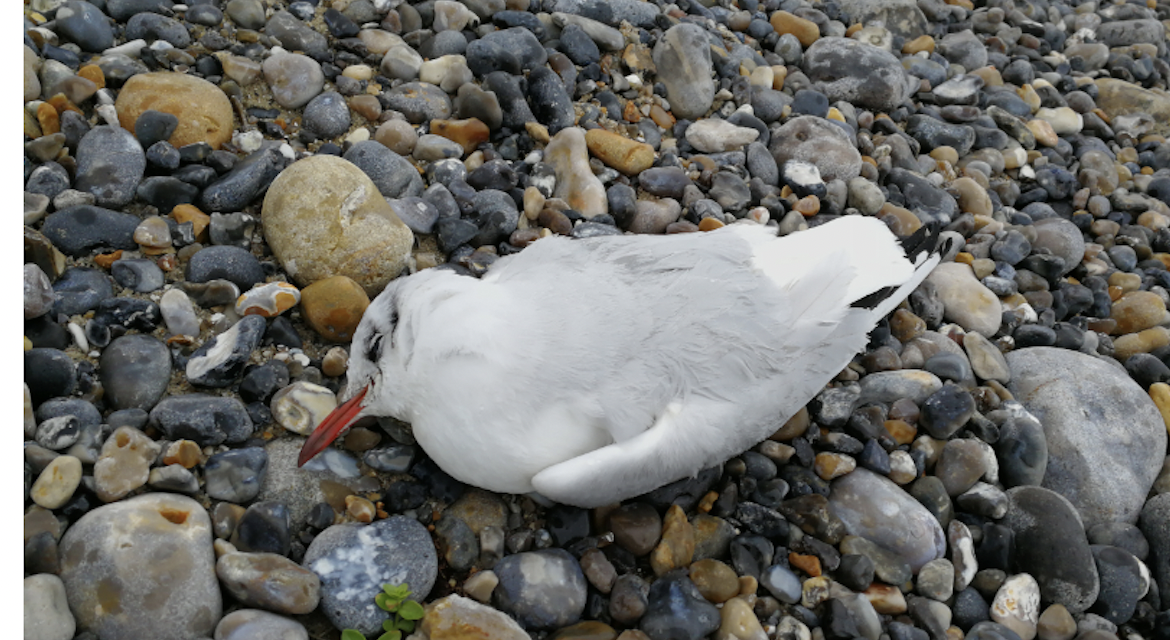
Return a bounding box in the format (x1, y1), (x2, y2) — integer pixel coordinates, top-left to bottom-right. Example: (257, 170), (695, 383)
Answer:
(262, 154), (414, 297)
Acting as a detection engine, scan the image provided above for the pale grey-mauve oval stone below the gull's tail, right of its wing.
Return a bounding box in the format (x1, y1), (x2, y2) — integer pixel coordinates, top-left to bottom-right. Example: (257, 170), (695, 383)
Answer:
(828, 469), (947, 573)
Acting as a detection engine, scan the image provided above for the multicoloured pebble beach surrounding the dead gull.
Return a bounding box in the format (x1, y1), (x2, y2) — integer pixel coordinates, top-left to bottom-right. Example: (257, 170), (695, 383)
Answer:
(22, 0), (1170, 640)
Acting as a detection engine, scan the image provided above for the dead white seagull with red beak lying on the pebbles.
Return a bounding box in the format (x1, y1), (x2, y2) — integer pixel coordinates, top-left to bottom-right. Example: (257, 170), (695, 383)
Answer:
(300, 215), (940, 507)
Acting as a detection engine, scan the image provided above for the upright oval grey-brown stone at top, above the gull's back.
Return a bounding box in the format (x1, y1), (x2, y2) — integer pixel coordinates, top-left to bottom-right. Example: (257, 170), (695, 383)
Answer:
(654, 23), (715, 119)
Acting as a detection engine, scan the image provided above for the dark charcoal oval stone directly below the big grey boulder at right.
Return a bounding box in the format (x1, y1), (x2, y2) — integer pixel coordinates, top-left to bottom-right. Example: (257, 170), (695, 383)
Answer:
(1002, 489), (1101, 613)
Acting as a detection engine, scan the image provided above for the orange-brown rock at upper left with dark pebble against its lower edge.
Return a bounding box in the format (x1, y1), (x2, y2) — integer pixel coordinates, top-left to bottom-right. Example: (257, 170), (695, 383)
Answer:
(115, 71), (233, 149)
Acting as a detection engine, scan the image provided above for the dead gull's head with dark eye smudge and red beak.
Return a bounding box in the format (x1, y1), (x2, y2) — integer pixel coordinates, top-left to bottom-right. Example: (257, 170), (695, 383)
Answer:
(297, 278), (413, 466)
